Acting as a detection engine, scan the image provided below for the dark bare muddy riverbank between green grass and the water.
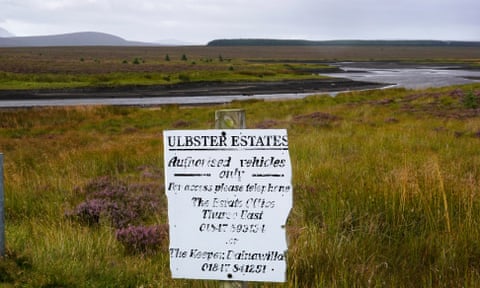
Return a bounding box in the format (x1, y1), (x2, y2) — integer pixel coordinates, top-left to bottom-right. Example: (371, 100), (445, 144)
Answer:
(0, 78), (385, 100)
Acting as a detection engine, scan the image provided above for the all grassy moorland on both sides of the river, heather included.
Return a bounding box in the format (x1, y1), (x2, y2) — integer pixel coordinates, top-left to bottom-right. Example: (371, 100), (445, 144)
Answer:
(0, 47), (480, 287)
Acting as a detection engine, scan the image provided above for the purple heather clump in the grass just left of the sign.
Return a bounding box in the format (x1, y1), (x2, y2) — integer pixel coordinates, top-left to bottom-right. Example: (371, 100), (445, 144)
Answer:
(66, 177), (168, 254)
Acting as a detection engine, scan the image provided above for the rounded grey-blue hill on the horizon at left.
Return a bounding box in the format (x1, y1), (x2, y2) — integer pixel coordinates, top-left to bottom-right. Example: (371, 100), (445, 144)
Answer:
(0, 32), (158, 47)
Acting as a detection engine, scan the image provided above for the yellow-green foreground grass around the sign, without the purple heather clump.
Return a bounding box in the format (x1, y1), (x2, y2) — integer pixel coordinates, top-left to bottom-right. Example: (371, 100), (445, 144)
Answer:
(0, 82), (480, 287)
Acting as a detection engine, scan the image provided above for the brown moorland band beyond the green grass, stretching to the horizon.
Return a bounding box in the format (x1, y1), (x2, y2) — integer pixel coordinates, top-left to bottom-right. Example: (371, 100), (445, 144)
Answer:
(0, 46), (480, 73)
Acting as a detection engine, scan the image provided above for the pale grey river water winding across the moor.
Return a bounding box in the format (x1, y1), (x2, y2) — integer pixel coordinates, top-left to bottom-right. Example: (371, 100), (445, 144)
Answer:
(0, 63), (480, 108)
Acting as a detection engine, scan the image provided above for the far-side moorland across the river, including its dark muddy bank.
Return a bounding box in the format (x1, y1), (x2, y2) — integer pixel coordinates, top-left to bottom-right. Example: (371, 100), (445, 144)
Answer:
(0, 45), (480, 99)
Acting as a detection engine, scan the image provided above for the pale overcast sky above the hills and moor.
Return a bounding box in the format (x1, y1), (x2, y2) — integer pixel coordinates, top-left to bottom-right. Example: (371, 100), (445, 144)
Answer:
(0, 0), (480, 44)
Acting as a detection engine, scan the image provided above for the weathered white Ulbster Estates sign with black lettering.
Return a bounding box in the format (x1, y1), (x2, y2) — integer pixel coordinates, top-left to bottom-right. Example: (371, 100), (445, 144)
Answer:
(163, 129), (292, 282)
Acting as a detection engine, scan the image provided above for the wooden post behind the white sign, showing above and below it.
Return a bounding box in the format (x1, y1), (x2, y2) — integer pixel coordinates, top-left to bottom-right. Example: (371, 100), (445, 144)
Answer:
(215, 109), (248, 288)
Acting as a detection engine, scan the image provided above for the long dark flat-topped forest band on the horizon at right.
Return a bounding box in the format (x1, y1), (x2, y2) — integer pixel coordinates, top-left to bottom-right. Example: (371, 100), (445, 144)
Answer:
(207, 39), (480, 47)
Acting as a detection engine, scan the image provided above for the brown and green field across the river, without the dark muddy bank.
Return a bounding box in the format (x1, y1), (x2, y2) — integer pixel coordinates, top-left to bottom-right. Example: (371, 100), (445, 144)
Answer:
(0, 46), (480, 90)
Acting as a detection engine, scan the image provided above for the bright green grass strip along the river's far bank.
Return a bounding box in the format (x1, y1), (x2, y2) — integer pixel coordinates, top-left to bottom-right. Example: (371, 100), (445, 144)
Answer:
(0, 55), (328, 90)
